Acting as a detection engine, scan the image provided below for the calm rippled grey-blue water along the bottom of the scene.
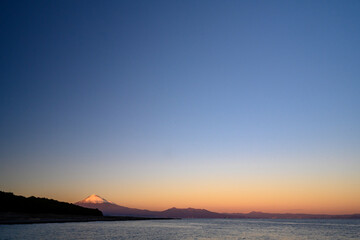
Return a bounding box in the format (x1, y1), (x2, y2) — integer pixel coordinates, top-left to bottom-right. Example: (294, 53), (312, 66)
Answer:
(0, 219), (360, 240)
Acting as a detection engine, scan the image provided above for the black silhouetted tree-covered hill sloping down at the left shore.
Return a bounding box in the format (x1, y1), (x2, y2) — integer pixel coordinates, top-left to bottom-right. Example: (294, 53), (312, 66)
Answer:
(0, 191), (103, 216)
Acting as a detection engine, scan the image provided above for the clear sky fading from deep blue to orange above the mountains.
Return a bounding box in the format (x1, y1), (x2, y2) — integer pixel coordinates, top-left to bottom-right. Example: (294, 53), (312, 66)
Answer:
(0, 0), (360, 214)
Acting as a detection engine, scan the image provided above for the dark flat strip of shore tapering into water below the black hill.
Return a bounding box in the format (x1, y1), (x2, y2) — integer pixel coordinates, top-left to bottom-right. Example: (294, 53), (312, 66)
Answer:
(0, 213), (171, 224)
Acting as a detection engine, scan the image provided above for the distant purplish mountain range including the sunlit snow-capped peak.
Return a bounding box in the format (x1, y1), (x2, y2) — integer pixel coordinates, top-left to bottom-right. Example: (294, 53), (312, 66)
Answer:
(75, 195), (360, 219)
